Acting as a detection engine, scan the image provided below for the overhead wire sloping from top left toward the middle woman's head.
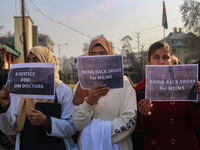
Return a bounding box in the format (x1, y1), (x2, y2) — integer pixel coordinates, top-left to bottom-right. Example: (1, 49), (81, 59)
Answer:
(30, 0), (92, 38)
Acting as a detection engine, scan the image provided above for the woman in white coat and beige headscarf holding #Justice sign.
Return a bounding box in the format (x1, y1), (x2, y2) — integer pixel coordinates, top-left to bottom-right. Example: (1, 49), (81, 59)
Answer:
(0, 46), (76, 150)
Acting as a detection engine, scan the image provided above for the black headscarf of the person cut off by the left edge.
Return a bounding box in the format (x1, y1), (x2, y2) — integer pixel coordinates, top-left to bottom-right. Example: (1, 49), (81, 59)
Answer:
(0, 52), (8, 90)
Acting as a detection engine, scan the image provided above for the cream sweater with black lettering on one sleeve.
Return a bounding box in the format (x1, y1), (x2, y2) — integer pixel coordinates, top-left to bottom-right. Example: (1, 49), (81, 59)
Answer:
(72, 79), (137, 149)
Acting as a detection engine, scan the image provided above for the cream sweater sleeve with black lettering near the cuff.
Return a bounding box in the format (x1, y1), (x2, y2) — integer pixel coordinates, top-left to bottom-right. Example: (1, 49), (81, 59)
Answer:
(111, 80), (137, 143)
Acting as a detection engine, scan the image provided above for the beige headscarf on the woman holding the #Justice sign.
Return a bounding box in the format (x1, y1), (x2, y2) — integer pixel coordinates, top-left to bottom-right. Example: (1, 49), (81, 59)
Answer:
(16, 46), (59, 132)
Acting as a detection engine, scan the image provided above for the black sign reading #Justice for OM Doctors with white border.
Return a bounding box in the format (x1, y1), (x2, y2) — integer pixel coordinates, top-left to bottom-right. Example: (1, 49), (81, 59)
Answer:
(7, 63), (55, 99)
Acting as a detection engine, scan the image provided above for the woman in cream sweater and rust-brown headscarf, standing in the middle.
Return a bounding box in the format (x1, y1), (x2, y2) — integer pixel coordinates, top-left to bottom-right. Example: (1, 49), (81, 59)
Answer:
(72, 38), (137, 150)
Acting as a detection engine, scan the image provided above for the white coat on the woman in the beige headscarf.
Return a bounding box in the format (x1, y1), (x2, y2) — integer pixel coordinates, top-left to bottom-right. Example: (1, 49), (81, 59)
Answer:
(0, 83), (77, 149)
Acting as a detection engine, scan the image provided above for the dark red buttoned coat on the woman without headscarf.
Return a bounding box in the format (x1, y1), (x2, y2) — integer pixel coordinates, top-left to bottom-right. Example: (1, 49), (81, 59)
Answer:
(134, 78), (200, 150)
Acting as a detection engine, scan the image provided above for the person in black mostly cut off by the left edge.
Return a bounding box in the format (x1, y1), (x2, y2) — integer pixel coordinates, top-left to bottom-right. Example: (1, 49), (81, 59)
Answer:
(0, 52), (15, 150)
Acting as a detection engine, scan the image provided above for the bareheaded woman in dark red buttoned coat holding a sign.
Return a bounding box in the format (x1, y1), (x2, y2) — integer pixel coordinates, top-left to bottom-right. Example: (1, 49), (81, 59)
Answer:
(133, 41), (200, 150)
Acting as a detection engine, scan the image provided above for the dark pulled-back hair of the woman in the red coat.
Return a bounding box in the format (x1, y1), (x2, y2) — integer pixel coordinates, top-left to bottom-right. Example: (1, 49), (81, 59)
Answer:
(148, 41), (172, 62)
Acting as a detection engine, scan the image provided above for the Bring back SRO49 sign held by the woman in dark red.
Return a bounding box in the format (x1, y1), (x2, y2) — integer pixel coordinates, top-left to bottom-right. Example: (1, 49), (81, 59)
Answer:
(145, 64), (198, 101)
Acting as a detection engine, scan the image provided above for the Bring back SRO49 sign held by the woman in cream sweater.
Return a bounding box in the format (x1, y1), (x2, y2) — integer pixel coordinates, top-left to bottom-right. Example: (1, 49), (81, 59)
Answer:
(77, 55), (124, 89)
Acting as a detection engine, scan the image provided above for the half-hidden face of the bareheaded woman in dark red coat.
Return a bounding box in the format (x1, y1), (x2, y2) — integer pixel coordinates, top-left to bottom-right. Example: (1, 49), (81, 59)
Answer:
(148, 48), (172, 65)
